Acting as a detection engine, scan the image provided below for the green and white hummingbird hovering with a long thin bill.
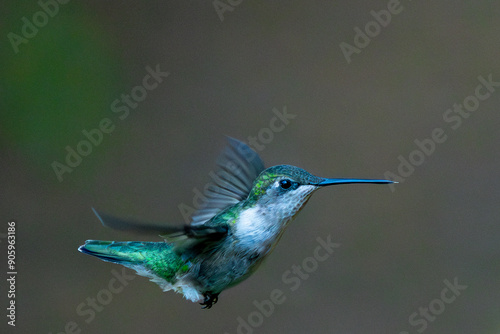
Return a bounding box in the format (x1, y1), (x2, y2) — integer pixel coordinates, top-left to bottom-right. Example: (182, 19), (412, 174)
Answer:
(78, 137), (396, 309)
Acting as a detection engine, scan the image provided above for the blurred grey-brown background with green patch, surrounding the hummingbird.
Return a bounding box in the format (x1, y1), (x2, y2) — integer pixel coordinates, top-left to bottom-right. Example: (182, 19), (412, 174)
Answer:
(0, 0), (500, 334)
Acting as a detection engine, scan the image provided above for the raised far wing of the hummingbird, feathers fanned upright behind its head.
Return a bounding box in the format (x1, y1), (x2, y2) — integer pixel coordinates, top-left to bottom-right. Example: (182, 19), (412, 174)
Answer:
(191, 137), (264, 225)
